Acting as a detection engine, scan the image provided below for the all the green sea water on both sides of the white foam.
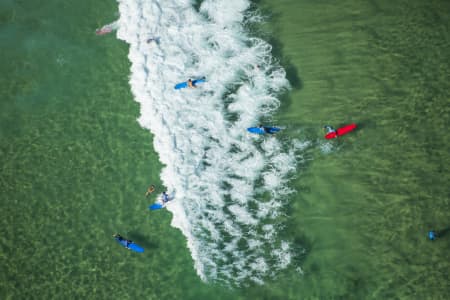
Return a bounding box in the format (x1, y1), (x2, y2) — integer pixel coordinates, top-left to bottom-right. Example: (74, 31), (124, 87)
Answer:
(0, 1), (450, 299)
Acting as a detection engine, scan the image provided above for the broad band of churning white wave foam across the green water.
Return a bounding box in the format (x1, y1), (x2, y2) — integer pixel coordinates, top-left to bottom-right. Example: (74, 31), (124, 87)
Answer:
(117, 0), (308, 285)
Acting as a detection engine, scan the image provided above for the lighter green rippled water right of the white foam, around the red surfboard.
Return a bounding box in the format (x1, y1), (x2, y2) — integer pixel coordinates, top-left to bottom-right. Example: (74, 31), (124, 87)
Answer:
(255, 1), (450, 299)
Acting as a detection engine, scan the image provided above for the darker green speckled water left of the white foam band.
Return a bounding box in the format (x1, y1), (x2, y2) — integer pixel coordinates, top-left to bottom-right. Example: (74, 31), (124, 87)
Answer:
(0, 2), (223, 299)
